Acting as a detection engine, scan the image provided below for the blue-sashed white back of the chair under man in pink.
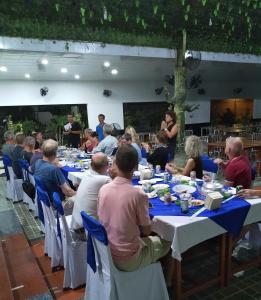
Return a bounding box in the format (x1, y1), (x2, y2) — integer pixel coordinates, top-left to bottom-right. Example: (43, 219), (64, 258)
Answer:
(81, 211), (110, 276)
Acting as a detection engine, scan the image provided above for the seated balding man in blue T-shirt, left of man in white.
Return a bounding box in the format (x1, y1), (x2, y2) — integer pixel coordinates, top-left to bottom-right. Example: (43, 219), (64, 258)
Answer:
(34, 139), (76, 199)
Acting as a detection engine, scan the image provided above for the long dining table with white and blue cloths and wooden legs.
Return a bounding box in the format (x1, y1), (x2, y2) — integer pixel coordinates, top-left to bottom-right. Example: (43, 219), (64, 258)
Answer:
(65, 170), (261, 300)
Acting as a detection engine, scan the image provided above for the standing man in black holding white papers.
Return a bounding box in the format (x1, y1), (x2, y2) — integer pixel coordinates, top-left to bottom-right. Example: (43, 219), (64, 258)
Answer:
(63, 114), (81, 148)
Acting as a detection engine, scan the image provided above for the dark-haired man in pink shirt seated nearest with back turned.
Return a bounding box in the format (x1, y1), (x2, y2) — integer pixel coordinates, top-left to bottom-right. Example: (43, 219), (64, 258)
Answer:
(98, 145), (170, 271)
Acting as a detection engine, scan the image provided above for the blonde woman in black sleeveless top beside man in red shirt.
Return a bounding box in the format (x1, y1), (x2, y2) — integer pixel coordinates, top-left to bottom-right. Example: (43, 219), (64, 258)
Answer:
(166, 135), (203, 179)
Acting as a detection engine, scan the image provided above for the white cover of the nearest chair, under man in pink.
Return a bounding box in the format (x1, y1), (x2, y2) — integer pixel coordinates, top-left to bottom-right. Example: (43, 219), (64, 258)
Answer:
(84, 238), (169, 300)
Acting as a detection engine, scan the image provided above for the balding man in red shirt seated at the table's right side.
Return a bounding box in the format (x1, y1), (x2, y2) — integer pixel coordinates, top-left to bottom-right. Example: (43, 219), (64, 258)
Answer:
(214, 137), (252, 189)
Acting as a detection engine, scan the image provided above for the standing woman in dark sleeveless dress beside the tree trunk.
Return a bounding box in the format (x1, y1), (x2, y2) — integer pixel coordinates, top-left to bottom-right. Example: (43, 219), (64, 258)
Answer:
(160, 110), (178, 160)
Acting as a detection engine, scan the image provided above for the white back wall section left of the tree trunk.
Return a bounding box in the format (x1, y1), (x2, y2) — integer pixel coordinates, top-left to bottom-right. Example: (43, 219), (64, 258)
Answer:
(0, 81), (163, 129)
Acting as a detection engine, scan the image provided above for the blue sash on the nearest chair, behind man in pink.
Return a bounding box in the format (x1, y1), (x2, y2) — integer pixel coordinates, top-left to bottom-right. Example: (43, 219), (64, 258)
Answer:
(81, 211), (108, 273)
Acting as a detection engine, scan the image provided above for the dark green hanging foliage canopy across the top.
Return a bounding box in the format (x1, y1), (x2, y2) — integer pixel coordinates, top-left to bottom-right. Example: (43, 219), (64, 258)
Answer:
(0, 0), (261, 54)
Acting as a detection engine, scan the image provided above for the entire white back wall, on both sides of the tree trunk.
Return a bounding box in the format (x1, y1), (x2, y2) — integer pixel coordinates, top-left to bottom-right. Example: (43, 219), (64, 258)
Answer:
(0, 81), (261, 129)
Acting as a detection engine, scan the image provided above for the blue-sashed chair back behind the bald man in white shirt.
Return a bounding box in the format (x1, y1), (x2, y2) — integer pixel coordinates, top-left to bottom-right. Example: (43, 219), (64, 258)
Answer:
(53, 192), (72, 243)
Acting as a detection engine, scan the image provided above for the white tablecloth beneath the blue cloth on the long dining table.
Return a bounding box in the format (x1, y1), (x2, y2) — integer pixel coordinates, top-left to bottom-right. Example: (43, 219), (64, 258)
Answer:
(68, 172), (261, 261)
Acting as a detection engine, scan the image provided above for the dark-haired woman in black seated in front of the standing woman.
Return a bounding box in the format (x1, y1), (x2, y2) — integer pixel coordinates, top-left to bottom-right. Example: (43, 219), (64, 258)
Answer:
(142, 131), (169, 170)
